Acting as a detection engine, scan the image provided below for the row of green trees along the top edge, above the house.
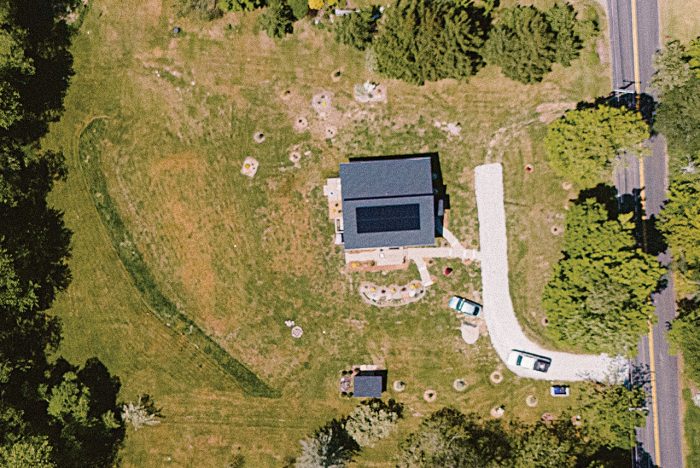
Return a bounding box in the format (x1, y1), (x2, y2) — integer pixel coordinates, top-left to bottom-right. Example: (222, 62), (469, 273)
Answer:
(179, 0), (598, 85)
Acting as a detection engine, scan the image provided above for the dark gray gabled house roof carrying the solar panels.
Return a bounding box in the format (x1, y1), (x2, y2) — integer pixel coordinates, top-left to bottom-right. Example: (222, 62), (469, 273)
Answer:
(340, 156), (435, 250)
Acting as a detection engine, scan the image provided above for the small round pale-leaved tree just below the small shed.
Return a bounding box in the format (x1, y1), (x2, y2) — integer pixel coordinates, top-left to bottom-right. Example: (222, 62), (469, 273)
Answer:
(345, 399), (402, 447)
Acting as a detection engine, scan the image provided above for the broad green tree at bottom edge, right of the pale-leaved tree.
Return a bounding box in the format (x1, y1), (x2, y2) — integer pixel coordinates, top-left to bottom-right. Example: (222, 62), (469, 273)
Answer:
(398, 408), (511, 468)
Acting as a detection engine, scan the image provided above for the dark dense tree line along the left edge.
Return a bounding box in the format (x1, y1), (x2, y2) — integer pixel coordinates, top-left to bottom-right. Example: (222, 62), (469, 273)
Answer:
(0, 0), (125, 467)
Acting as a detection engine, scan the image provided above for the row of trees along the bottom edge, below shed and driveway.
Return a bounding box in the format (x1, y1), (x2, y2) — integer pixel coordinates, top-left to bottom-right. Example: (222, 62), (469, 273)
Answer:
(285, 383), (645, 468)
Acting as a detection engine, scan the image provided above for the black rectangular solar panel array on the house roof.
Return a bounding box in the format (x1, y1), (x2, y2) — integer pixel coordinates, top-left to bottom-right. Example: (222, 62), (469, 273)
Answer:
(355, 203), (420, 234)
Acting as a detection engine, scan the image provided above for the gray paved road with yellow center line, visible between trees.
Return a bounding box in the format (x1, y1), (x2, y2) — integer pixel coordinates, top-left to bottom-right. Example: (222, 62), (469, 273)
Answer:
(608, 0), (683, 468)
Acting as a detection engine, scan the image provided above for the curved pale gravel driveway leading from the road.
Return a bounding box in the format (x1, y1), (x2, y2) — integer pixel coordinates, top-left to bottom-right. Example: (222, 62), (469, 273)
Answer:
(475, 163), (627, 381)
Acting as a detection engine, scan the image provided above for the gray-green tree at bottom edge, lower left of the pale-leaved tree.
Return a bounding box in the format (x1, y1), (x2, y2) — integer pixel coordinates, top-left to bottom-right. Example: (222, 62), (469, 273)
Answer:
(296, 419), (359, 468)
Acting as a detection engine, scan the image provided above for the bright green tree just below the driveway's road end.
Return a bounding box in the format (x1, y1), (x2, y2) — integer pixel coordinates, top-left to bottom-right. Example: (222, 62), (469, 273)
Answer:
(578, 383), (647, 449)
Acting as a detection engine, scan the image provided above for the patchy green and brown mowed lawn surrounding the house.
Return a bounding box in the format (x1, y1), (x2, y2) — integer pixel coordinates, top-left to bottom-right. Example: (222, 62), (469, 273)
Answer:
(46, 0), (609, 466)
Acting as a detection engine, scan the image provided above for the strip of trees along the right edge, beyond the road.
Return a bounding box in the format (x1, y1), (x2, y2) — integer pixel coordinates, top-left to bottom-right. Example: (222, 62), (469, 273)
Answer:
(652, 37), (700, 383)
